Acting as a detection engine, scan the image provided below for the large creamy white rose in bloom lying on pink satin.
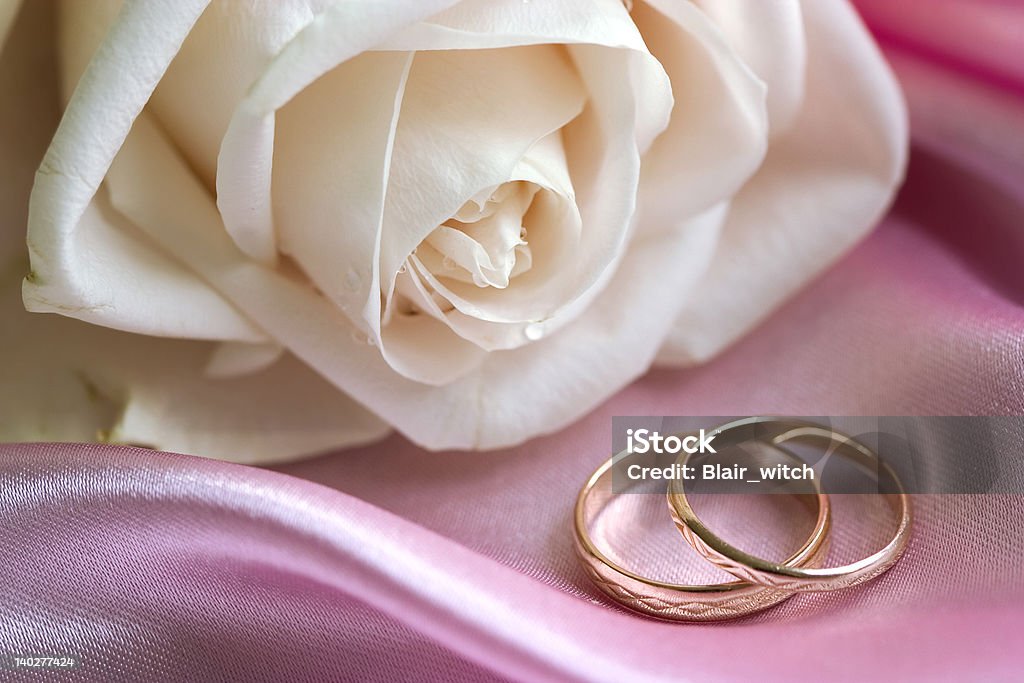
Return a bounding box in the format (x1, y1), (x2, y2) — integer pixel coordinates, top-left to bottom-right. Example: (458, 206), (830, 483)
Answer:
(8, 0), (906, 459)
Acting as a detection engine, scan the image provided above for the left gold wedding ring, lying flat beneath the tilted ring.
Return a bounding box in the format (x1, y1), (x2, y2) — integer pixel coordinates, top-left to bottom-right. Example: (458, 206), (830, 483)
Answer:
(574, 440), (831, 622)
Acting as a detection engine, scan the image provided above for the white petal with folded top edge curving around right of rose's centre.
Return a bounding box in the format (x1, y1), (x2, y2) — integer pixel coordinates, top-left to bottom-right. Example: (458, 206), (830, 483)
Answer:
(374, 0), (678, 366)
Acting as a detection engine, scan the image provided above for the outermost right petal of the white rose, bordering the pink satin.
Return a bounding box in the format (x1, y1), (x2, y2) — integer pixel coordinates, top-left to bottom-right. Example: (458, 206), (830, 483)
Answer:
(659, 0), (907, 364)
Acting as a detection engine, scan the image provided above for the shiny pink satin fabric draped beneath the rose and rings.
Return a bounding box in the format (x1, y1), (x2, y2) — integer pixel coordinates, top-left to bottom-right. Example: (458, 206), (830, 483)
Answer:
(0, 0), (1024, 682)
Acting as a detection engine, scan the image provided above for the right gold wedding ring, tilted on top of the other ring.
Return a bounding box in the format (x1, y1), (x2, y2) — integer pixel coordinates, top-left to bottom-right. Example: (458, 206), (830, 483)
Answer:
(668, 418), (911, 591)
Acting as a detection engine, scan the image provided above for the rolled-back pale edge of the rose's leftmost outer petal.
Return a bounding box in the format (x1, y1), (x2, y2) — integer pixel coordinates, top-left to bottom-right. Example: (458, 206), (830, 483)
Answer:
(24, 0), (218, 333)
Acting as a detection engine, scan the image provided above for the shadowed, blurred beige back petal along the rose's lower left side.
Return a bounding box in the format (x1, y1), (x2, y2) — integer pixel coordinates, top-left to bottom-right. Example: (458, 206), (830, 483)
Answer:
(0, 2), (390, 463)
